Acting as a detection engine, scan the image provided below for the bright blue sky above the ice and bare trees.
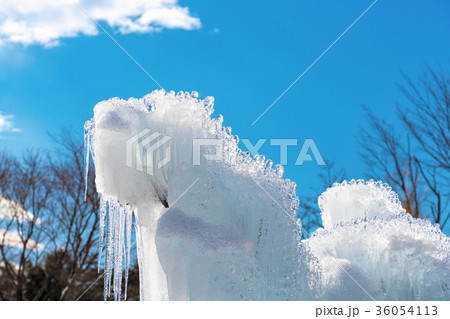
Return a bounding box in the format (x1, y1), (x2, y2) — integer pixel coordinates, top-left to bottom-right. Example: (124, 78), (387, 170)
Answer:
(0, 0), (450, 212)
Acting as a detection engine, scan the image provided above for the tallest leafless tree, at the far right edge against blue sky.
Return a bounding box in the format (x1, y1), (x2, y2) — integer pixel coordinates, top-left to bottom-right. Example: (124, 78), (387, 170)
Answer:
(397, 65), (450, 228)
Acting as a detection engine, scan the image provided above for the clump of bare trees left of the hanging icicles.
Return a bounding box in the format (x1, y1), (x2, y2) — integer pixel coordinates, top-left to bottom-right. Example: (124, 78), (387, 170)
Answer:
(0, 130), (139, 300)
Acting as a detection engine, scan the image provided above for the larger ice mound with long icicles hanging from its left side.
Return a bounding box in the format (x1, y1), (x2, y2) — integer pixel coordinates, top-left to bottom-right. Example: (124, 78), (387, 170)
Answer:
(86, 90), (302, 300)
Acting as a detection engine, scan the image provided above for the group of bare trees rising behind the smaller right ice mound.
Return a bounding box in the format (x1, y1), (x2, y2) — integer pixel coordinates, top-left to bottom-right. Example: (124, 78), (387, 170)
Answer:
(359, 66), (450, 229)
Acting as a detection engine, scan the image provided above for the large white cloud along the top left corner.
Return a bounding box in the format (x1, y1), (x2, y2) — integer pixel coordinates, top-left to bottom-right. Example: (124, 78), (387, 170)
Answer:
(0, 0), (201, 47)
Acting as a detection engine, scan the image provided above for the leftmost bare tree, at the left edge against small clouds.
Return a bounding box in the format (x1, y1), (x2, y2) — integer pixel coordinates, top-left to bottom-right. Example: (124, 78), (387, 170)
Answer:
(0, 151), (51, 300)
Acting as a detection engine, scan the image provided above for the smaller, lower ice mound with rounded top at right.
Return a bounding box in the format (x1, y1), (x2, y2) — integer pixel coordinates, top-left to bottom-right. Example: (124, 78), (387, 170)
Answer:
(301, 180), (450, 300)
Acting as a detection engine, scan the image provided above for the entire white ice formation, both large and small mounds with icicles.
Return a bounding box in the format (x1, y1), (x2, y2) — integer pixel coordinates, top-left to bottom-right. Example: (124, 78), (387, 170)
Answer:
(85, 90), (450, 300)
